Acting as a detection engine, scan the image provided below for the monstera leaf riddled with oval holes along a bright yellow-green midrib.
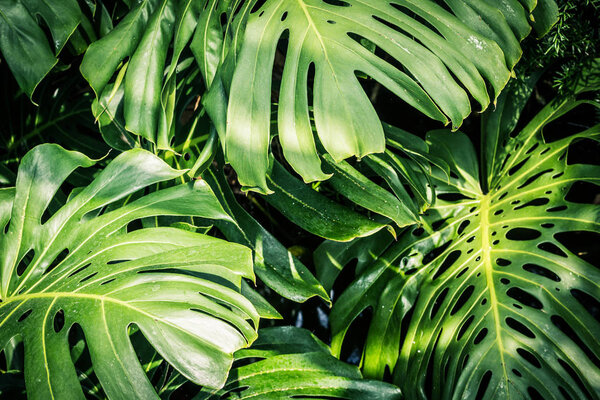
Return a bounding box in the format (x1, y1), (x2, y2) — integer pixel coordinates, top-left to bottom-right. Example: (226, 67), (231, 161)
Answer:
(321, 83), (600, 399)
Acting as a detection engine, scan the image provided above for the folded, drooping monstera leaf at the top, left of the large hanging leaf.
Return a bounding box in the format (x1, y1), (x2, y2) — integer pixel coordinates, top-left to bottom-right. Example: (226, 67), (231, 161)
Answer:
(81, 0), (214, 149)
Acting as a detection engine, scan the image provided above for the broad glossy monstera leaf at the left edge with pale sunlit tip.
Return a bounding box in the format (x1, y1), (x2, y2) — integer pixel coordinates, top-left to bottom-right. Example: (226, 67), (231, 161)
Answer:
(0, 144), (258, 399)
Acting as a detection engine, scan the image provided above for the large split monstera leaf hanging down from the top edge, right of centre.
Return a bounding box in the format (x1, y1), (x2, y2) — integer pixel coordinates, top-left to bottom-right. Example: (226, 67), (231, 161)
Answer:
(207, 0), (556, 193)
